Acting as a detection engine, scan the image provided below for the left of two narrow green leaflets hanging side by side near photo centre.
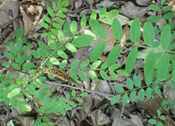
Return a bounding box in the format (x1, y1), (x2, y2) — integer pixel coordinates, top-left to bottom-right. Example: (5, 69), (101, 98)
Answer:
(70, 59), (80, 81)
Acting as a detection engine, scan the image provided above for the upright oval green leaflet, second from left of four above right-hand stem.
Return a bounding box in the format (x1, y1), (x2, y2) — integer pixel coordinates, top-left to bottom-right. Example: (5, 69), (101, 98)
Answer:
(130, 19), (141, 43)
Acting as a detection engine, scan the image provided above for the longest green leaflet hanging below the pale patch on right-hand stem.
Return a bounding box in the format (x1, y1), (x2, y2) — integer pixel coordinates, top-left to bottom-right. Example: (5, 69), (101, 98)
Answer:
(144, 52), (158, 85)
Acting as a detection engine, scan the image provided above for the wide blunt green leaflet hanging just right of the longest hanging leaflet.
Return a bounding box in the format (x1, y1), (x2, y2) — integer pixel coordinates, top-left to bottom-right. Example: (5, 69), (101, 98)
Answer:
(156, 54), (170, 81)
